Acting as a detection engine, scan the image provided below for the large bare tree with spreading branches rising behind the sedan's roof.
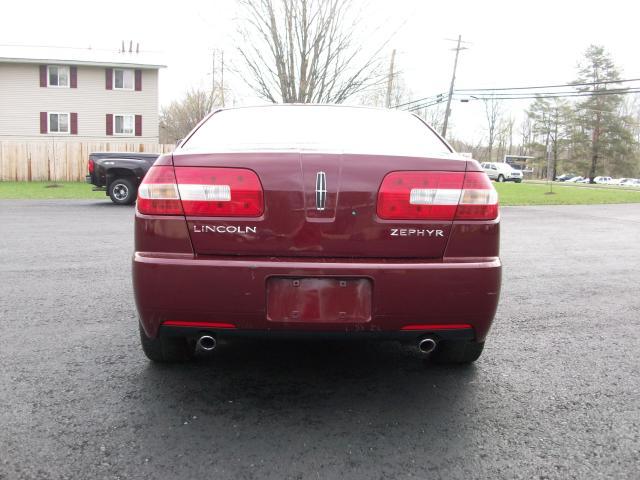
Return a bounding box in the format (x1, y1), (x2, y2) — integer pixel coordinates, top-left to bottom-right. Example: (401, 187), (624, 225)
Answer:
(238, 0), (386, 103)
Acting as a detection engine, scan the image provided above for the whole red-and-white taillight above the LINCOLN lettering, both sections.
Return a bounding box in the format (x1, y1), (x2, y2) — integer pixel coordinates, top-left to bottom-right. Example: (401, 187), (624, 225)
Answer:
(138, 166), (264, 217)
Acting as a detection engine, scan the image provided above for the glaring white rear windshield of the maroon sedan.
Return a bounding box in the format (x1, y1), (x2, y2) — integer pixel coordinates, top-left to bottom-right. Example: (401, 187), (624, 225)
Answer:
(181, 106), (451, 156)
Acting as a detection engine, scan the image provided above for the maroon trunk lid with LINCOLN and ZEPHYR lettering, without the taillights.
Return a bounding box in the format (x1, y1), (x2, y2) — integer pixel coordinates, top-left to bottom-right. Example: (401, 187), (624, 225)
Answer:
(173, 150), (466, 259)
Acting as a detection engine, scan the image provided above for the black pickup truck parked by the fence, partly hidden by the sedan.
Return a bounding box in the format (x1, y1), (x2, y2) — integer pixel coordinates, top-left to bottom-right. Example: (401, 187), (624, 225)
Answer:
(86, 152), (159, 205)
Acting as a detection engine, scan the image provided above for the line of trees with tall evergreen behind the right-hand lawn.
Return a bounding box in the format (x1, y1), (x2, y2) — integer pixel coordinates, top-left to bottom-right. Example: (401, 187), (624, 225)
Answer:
(453, 45), (640, 180)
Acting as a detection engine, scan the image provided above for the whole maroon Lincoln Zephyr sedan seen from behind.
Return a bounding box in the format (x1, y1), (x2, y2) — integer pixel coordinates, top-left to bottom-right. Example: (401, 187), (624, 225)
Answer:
(133, 105), (501, 363)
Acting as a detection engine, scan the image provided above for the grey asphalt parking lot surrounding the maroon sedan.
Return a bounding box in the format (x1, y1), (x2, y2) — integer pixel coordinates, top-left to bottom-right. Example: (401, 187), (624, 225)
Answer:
(0, 200), (640, 479)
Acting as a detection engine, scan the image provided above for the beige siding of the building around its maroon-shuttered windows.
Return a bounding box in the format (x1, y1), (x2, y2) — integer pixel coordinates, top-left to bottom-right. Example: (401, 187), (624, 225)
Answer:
(0, 63), (158, 142)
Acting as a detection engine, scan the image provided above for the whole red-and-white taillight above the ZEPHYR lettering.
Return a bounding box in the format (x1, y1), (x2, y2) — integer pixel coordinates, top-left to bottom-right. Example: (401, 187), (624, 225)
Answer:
(377, 171), (498, 220)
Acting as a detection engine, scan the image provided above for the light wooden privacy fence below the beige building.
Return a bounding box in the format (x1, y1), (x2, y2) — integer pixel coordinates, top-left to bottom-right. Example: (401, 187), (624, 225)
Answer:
(0, 141), (175, 182)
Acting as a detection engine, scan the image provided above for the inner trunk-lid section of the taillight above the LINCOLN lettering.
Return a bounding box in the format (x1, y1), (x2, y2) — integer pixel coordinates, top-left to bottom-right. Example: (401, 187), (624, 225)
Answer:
(176, 167), (264, 217)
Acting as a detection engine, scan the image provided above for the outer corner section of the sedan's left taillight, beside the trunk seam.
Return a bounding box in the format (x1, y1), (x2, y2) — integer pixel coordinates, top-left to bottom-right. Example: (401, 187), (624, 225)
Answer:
(137, 166), (183, 215)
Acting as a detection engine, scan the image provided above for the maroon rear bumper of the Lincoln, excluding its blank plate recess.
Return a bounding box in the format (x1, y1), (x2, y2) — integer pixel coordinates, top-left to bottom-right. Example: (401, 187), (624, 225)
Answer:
(133, 252), (501, 341)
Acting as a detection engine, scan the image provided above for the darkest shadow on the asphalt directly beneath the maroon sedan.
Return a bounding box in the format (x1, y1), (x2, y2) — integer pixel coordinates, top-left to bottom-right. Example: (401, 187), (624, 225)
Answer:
(140, 339), (477, 415)
